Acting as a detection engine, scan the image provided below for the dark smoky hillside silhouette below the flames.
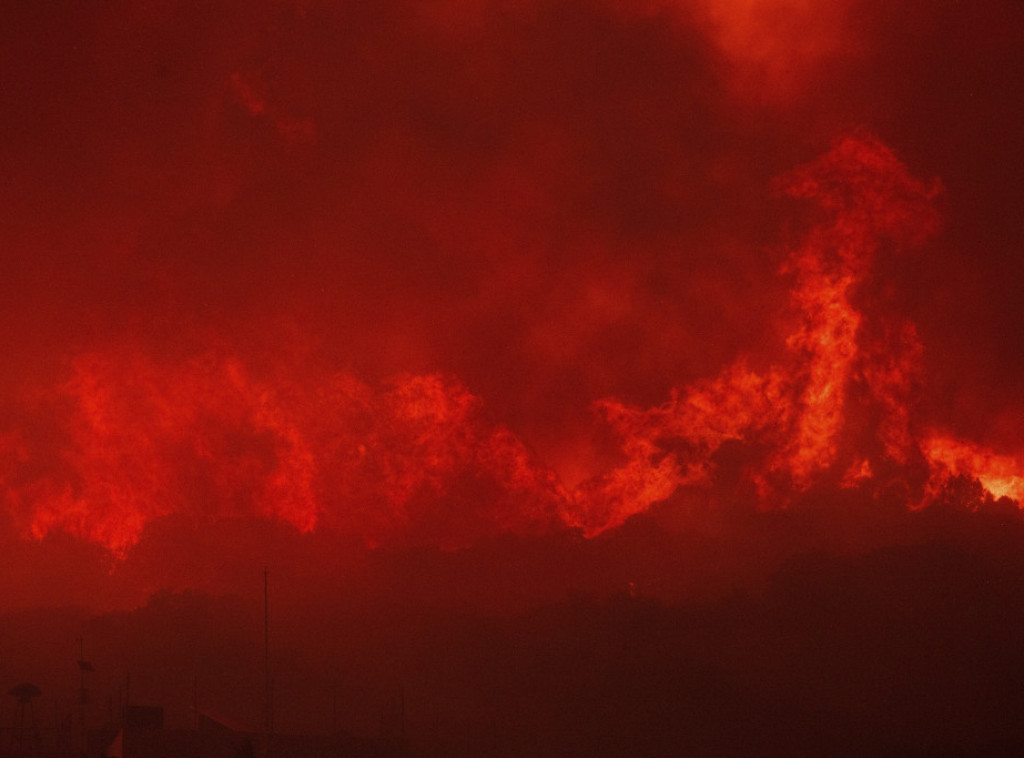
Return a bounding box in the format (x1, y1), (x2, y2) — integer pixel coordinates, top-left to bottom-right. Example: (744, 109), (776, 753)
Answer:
(0, 500), (1024, 756)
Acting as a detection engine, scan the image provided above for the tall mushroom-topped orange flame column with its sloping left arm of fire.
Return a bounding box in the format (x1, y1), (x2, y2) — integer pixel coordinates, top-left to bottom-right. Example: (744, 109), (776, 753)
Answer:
(573, 138), (938, 532)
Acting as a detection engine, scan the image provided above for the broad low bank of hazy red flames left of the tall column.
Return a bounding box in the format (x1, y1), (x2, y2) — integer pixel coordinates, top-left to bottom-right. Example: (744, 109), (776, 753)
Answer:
(5, 352), (565, 554)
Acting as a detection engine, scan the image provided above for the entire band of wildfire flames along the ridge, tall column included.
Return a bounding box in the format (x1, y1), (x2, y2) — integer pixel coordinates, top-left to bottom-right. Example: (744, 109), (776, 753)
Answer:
(0, 136), (1024, 554)
